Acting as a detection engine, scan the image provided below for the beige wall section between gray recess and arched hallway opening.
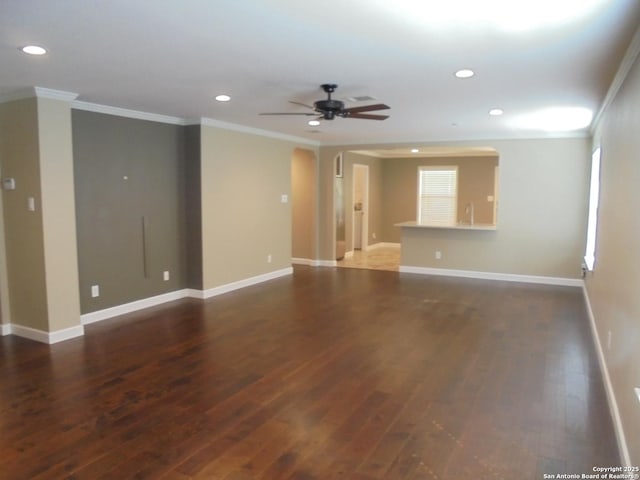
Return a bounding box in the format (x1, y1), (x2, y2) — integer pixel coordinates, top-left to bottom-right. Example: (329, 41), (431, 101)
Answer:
(201, 125), (296, 290)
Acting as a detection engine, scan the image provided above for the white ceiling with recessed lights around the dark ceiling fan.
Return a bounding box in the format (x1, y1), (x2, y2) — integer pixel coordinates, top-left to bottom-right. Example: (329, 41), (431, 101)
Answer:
(0, 0), (640, 144)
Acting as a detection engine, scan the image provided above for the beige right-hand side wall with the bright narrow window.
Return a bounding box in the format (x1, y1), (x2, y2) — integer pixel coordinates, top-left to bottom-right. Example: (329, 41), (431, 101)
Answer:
(586, 50), (640, 465)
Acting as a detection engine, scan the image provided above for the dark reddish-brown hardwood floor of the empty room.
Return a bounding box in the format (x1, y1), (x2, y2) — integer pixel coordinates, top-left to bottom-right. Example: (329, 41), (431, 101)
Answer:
(0, 267), (620, 480)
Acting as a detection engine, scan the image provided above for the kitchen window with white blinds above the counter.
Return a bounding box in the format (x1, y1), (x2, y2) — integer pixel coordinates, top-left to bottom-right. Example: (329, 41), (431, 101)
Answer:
(418, 165), (458, 226)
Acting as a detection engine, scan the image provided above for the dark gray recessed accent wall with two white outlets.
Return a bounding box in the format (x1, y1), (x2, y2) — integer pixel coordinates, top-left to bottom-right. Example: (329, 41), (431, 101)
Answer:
(72, 110), (188, 313)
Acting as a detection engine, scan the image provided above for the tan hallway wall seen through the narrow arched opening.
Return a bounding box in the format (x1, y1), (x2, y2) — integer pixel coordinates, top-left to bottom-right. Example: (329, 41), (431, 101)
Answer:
(291, 148), (318, 260)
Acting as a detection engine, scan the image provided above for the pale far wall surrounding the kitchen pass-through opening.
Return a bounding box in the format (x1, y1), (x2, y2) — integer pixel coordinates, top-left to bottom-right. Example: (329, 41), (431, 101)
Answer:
(320, 138), (591, 278)
